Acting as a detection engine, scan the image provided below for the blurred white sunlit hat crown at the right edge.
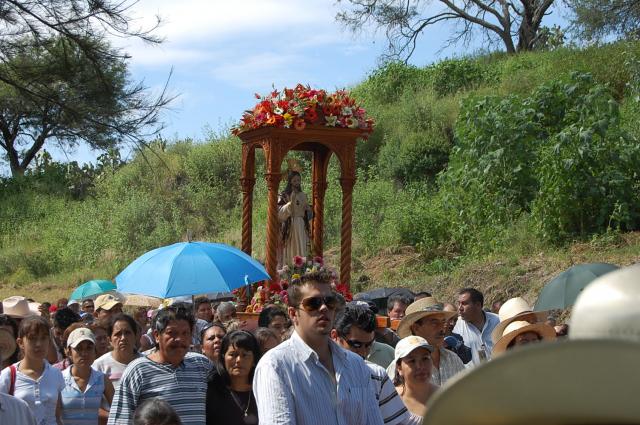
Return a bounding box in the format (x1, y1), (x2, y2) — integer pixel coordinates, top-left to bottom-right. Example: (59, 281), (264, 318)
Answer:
(569, 264), (640, 342)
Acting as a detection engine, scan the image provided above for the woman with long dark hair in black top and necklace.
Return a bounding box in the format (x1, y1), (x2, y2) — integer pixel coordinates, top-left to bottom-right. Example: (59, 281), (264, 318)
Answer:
(207, 331), (260, 425)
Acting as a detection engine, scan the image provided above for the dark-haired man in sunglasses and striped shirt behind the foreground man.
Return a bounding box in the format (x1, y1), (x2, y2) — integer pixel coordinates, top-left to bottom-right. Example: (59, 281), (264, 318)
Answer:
(331, 301), (421, 425)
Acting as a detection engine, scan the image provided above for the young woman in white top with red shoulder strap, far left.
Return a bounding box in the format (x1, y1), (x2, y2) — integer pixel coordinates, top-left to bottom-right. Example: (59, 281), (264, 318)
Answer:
(0, 316), (64, 425)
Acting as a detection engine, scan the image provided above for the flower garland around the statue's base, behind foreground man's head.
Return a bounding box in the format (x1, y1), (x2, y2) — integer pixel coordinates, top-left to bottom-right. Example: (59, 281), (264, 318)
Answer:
(245, 256), (353, 313)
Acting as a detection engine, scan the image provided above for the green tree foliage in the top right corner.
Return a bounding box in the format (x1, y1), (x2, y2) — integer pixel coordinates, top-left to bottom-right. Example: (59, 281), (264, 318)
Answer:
(566, 0), (640, 40)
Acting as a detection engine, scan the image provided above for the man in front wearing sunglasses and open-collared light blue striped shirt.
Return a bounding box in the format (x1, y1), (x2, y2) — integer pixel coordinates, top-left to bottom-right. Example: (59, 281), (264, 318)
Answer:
(253, 269), (384, 425)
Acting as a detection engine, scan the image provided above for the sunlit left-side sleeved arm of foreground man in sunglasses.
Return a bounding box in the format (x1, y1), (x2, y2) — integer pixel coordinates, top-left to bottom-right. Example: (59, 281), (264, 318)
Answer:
(253, 361), (296, 425)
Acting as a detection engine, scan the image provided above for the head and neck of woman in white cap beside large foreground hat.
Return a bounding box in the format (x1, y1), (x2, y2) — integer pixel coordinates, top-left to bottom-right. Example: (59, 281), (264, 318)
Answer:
(393, 335), (438, 418)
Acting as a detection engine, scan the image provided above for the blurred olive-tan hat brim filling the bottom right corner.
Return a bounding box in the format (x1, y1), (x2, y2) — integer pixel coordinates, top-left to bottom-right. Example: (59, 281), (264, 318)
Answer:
(423, 340), (640, 425)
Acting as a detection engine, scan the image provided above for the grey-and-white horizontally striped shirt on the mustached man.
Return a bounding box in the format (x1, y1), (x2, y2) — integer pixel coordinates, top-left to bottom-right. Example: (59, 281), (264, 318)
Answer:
(108, 353), (213, 425)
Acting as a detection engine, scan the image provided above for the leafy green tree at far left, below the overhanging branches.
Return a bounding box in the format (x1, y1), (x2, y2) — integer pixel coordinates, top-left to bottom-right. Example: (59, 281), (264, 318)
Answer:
(0, 37), (165, 176)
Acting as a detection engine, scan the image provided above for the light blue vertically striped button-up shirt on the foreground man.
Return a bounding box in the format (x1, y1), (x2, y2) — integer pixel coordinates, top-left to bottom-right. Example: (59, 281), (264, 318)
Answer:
(253, 332), (384, 425)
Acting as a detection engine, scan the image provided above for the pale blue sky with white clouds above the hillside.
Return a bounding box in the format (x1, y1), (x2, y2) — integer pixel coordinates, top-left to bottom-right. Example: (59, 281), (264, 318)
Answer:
(38, 0), (559, 167)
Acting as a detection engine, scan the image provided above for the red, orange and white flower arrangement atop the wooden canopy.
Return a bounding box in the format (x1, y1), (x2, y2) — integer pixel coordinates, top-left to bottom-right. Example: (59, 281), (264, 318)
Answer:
(231, 84), (374, 137)
